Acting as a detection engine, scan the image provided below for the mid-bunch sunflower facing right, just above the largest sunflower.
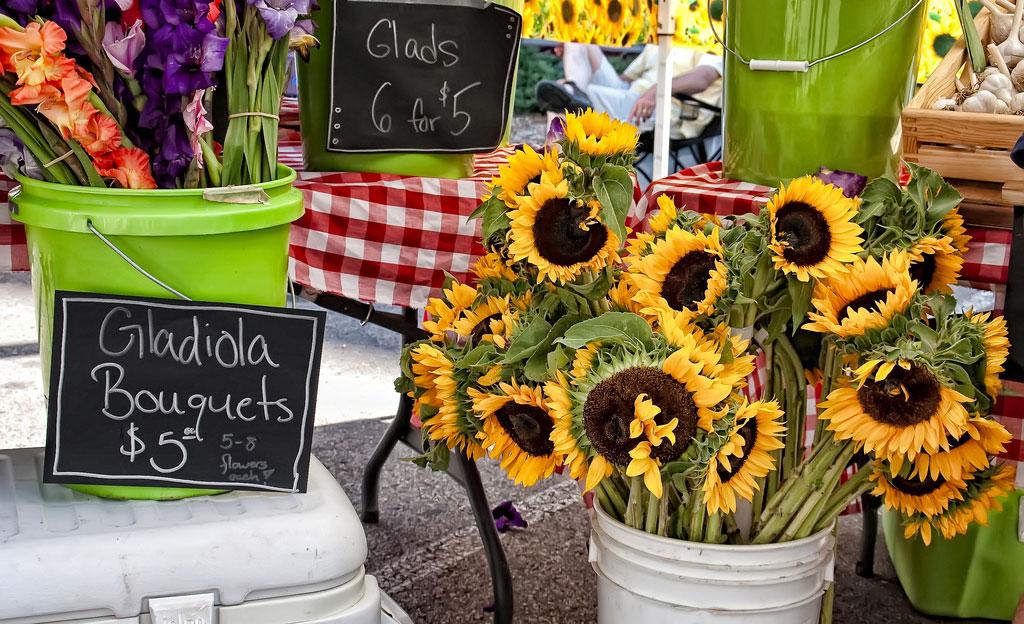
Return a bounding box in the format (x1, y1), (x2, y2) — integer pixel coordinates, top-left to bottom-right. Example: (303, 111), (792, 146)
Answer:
(629, 225), (728, 316)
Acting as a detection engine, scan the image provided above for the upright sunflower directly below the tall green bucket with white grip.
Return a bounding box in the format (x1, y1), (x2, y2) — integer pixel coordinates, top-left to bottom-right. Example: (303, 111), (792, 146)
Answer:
(768, 175), (863, 282)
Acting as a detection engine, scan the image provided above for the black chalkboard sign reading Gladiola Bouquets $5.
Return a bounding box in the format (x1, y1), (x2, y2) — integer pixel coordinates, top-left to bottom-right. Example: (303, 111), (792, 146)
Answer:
(44, 291), (326, 492)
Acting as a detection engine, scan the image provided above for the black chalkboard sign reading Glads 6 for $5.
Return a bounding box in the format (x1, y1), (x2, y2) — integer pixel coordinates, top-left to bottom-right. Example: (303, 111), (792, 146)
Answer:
(327, 0), (522, 154)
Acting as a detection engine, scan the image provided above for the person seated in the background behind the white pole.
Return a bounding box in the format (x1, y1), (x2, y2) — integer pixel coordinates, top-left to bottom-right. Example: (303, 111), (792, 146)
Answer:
(537, 43), (722, 138)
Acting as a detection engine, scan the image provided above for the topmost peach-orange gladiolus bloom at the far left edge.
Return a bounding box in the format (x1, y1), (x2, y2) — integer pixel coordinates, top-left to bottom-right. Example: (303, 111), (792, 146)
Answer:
(0, 22), (68, 85)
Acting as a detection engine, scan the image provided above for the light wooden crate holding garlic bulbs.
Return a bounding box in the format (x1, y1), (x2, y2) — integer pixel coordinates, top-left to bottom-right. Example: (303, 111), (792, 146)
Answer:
(903, 9), (1024, 228)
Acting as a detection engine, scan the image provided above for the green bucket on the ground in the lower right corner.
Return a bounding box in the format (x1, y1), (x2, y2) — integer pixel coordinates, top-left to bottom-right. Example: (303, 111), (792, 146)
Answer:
(883, 490), (1024, 620)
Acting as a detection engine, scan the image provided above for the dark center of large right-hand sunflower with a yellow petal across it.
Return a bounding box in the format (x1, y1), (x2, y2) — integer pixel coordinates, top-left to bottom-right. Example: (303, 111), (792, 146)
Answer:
(857, 364), (941, 427)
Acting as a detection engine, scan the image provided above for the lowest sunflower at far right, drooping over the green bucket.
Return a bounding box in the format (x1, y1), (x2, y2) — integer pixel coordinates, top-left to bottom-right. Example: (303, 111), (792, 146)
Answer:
(903, 464), (1016, 545)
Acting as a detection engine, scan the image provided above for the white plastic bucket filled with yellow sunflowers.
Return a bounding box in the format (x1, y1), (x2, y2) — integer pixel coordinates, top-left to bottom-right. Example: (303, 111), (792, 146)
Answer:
(396, 112), (1013, 623)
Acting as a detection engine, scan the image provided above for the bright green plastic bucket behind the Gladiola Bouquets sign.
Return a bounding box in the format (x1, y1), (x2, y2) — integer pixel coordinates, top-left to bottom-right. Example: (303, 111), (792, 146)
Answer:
(10, 167), (303, 500)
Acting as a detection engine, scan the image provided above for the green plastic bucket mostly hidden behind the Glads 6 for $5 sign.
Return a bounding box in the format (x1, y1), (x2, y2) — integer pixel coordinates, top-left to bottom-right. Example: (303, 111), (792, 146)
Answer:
(298, 0), (523, 179)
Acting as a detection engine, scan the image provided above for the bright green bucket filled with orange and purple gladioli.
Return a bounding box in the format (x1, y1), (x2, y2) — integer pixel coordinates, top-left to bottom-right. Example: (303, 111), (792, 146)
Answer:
(0, 0), (311, 498)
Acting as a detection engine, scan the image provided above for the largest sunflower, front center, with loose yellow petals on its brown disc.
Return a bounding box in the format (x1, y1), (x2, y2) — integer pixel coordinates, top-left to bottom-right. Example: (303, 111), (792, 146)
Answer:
(545, 338), (732, 493)
